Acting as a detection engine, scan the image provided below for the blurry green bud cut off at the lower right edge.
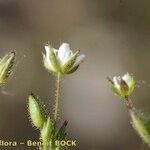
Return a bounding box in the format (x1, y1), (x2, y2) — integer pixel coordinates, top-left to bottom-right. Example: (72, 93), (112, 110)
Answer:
(130, 110), (150, 147)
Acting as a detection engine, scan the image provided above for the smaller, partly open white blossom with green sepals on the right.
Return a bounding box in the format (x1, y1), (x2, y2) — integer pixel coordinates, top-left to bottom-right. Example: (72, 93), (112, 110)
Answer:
(108, 73), (136, 97)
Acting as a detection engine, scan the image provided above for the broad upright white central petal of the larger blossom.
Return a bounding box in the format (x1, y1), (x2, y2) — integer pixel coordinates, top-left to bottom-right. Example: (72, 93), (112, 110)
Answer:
(58, 43), (71, 63)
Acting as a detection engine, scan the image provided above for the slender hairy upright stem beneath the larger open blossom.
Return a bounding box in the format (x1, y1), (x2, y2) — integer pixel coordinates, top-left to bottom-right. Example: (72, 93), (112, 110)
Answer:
(54, 74), (61, 123)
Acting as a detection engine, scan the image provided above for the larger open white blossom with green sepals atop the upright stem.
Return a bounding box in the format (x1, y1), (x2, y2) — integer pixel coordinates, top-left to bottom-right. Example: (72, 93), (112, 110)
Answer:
(43, 43), (85, 74)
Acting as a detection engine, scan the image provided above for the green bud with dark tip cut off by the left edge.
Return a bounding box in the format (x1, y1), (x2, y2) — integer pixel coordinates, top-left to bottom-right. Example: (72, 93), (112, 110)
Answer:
(0, 51), (16, 85)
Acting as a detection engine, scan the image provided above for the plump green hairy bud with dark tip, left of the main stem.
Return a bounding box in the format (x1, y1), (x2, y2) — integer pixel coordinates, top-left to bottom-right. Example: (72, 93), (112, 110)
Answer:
(28, 93), (46, 129)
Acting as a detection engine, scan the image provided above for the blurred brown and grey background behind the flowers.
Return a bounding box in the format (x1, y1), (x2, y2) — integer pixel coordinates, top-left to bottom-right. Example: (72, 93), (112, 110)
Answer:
(0, 0), (150, 150)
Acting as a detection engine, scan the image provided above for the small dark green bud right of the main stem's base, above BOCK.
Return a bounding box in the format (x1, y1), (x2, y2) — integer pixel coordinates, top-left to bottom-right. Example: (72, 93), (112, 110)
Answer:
(56, 121), (68, 141)
